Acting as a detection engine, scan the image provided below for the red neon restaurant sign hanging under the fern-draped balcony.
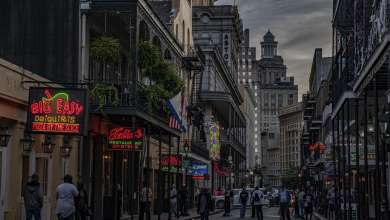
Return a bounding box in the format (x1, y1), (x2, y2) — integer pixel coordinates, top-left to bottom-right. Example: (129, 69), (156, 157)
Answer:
(108, 127), (145, 151)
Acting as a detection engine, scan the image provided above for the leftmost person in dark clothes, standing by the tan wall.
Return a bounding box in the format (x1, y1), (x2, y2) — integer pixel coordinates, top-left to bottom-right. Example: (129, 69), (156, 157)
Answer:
(23, 174), (43, 220)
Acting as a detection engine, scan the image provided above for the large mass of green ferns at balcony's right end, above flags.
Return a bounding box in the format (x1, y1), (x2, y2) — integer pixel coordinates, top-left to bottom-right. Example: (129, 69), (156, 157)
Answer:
(138, 42), (184, 112)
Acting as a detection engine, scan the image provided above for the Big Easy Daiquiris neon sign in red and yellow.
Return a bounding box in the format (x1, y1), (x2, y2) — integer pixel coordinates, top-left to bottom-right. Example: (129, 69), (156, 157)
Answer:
(27, 87), (87, 135)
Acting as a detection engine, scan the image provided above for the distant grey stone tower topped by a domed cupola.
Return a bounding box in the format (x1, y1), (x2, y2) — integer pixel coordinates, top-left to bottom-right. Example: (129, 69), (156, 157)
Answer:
(255, 31), (298, 186)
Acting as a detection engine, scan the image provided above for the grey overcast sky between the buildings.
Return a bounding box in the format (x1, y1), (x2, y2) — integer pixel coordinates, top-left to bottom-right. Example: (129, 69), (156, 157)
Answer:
(217, 0), (332, 95)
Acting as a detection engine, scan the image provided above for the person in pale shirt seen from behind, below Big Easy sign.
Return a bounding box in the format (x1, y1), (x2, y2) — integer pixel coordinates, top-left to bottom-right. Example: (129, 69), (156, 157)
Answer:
(55, 175), (79, 220)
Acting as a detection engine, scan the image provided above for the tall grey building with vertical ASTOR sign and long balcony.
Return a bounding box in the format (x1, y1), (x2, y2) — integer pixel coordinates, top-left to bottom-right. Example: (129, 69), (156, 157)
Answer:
(193, 5), (247, 189)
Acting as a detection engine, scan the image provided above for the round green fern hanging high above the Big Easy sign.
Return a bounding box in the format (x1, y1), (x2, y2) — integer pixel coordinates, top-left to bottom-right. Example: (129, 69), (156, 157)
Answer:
(90, 36), (120, 63)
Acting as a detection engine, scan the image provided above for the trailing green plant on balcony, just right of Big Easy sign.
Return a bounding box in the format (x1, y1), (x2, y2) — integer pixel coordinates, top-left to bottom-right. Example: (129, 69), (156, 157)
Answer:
(90, 83), (119, 113)
